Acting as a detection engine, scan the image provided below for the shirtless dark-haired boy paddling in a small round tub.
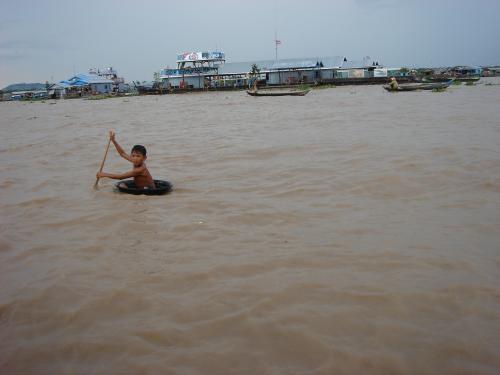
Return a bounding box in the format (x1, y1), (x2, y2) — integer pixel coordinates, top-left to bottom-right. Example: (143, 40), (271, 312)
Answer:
(97, 130), (155, 189)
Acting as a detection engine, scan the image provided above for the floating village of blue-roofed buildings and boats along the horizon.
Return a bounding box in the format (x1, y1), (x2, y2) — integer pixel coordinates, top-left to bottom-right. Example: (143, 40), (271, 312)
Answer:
(0, 51), (500, 101)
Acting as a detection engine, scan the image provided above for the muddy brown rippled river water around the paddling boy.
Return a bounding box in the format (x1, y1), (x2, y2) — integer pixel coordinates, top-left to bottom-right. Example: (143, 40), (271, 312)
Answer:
(0, 79), (500, 375)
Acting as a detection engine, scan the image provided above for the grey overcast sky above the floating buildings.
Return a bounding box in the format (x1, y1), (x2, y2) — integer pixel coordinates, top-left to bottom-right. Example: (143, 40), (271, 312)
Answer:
(0, 0), (500, 87)
